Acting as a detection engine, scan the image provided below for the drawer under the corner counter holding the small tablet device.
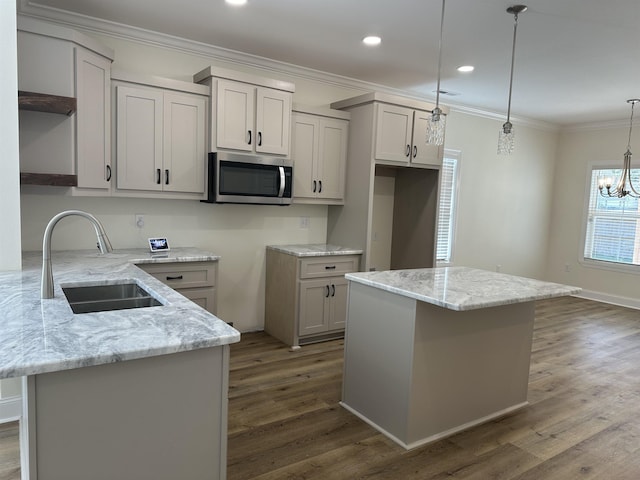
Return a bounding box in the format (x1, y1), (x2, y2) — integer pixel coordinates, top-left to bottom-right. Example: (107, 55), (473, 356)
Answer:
(138, 262), (216, 290)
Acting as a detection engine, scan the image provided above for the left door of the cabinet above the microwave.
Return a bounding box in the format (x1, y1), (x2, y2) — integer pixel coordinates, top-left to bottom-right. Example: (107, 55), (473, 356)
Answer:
(216, 80), (256, 152)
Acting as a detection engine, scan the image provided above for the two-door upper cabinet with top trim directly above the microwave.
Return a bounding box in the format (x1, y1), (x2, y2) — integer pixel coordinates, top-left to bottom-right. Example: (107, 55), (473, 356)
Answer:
(193, 67), (295, 156)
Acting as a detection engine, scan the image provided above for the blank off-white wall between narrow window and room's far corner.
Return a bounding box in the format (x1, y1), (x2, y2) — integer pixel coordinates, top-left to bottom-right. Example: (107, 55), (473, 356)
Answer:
(445, 111), (558, 279)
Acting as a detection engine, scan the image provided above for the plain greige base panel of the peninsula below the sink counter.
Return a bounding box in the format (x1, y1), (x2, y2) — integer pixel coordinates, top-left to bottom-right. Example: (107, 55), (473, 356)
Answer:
(21, 345), (229, 480)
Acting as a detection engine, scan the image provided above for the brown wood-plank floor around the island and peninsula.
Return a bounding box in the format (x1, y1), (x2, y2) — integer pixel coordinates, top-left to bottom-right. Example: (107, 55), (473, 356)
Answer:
(0, 297), (640, 480)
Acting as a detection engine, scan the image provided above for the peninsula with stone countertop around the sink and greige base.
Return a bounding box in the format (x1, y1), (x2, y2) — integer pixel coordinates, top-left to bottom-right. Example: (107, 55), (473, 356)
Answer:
(0, 249), (240, 480)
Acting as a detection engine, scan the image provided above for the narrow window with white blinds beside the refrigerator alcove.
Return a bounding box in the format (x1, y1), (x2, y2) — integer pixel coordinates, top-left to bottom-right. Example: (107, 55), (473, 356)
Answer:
(436, 150), (460, 265)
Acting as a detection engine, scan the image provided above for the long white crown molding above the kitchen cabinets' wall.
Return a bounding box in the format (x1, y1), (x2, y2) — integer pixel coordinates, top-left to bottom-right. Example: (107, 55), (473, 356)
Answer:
(17, 0), (559, 131)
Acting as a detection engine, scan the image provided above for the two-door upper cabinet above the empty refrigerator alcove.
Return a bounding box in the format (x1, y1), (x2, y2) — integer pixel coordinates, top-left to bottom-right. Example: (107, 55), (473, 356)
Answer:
(375, 103), (442, 166)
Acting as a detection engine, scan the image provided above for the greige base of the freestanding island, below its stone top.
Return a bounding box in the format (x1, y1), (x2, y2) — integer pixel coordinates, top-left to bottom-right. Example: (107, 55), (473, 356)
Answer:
(342, 281), (534, 449)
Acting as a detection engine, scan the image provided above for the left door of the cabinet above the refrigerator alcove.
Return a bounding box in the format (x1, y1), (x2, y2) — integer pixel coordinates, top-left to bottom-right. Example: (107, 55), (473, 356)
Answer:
(375, 104), (413, 165)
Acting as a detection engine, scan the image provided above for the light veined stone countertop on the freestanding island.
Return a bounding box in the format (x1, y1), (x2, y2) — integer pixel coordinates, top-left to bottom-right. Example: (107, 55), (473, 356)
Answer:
(345, 267), (582, 310)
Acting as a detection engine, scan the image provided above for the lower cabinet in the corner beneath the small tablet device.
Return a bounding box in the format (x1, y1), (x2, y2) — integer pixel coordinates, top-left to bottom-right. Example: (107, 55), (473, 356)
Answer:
(138, 261), (218, 315)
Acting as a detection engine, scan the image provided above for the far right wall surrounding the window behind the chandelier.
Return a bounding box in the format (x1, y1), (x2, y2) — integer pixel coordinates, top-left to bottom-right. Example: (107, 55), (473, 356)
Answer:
(547, 126), (640, 307)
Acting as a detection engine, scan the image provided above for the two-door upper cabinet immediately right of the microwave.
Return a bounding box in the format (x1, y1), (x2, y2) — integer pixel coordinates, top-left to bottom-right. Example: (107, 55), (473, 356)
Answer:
(291, 107), (349, 205)
